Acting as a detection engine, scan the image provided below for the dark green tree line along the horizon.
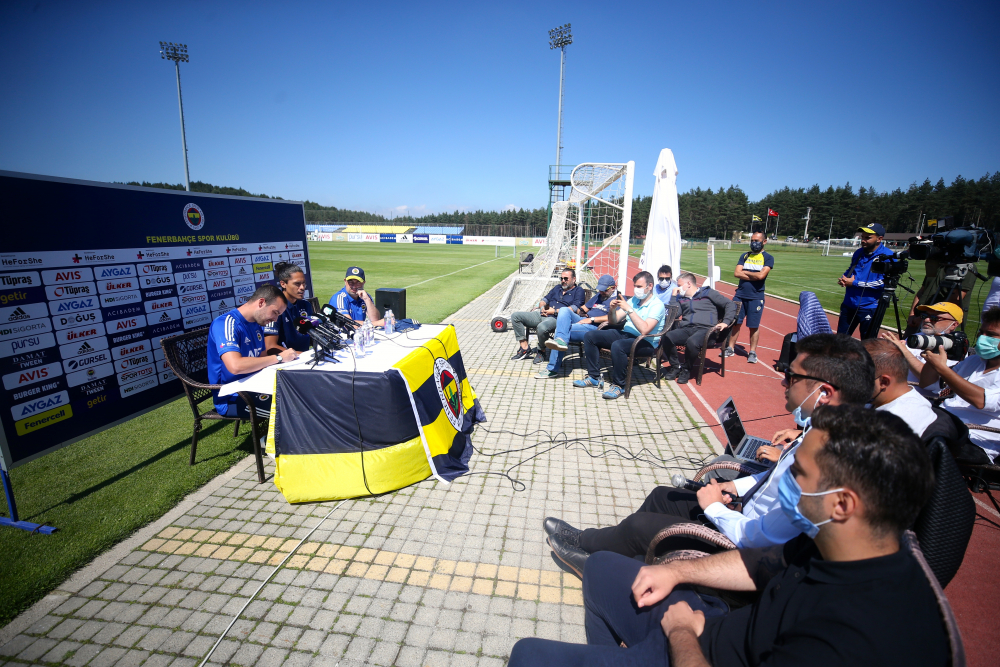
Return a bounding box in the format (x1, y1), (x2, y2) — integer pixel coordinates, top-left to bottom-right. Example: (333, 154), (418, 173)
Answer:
(127, 172), (1000, 239)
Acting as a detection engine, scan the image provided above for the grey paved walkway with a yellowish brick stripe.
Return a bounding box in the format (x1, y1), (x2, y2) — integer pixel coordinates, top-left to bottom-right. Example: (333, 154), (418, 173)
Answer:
(0, 276), (721, 667)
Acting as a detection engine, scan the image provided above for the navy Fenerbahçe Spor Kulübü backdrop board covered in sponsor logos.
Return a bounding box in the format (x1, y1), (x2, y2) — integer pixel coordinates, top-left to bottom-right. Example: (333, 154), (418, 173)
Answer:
(0, 171), (312, 469)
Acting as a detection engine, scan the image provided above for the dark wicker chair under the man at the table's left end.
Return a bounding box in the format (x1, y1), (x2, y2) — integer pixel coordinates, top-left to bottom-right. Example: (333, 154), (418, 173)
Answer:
(160, 327), (270, 484)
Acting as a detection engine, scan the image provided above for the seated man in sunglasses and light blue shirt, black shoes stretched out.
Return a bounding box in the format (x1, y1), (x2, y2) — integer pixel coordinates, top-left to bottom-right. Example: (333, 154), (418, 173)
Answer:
(542, 334), (875, 574)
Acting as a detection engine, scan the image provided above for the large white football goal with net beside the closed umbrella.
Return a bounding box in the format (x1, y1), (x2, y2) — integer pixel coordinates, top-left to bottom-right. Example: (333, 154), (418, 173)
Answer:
(491, 162), (635, 330)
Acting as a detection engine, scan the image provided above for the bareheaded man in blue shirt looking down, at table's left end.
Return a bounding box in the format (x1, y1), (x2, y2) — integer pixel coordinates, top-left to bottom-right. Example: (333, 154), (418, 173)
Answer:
(208, 284), (299, 419)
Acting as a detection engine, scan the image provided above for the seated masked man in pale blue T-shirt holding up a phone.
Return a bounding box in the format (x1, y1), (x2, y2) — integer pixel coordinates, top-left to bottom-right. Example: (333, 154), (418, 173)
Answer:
(573, 271), (667, 399)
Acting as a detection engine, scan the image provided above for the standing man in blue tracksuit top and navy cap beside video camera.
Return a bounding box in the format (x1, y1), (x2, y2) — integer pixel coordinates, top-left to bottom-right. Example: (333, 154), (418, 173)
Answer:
(837, 222), (892, 338)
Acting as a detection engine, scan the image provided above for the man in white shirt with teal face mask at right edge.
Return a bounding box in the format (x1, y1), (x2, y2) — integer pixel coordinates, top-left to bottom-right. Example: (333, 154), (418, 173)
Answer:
(920, 308), (1000, 463)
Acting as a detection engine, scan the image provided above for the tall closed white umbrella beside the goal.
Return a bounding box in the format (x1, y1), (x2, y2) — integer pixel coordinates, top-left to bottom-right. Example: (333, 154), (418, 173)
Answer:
(639, 148), (681, 279)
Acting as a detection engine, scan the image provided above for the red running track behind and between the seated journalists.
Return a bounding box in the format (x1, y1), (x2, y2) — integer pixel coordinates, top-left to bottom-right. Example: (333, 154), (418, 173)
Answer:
(626, 258), (1000, 667)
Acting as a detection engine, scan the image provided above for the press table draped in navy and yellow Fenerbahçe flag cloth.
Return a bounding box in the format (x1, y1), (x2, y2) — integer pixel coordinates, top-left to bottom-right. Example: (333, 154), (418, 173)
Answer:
(219, 324), (485, 502)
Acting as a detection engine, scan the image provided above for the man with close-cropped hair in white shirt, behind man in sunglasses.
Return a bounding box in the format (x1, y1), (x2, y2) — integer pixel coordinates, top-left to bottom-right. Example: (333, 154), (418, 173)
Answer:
(862, 338), (938, 438)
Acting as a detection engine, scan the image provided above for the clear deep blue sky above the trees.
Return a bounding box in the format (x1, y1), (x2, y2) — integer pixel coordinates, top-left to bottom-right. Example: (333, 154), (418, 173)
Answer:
(0, 0), (1000, 215)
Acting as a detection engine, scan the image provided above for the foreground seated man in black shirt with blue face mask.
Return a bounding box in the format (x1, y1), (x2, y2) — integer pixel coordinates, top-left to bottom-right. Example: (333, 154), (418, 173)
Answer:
(508, 405), (951, 667)
